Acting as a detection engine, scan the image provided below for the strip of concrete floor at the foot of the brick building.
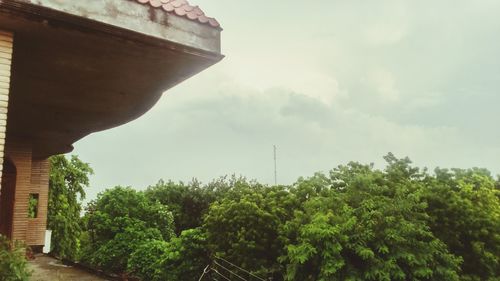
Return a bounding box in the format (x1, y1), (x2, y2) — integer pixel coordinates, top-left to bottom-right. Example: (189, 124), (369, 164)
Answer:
(29, 255), (107, 281)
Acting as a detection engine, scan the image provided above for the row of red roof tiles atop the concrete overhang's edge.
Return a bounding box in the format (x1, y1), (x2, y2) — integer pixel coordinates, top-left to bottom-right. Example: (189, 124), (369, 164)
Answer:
(135, 0), (220, 28)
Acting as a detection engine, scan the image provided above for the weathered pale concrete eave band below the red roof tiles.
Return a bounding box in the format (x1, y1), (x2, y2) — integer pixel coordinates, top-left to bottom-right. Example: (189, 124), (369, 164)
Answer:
(0, 0), (224, 56)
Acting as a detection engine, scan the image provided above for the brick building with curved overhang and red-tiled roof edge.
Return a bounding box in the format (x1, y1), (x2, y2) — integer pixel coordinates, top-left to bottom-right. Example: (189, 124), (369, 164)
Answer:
(0, 0), (223, 246)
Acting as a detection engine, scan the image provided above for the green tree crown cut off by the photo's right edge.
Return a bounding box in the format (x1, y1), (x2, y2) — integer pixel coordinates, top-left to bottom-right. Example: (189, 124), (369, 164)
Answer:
(425, 169), (500, 281)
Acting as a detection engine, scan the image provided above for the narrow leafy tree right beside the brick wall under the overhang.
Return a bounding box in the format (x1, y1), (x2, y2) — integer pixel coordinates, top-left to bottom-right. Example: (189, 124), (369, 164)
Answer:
(47, 155), (93, 260)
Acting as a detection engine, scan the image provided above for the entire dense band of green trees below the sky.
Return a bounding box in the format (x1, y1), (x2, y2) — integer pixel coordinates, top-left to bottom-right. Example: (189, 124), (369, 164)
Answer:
(45, 154), (500, 281)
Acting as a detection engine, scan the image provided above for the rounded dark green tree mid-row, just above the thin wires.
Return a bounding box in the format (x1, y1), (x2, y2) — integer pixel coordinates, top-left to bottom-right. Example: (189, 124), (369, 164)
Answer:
(203, 182), (296, 276)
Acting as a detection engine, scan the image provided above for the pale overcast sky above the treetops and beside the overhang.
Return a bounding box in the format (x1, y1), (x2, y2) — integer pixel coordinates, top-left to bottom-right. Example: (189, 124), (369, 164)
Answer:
(73, 0), (500, 199)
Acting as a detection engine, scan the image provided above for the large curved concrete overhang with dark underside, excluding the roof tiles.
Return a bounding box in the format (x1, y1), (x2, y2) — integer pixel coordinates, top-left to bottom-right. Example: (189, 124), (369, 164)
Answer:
(0, 0), (223, 157)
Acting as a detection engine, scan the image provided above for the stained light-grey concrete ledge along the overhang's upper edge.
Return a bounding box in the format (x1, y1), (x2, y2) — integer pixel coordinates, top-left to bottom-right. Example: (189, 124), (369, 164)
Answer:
(0, 0), (221, 54)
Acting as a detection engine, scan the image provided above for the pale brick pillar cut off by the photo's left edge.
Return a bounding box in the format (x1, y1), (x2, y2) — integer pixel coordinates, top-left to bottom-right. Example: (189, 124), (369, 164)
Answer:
(0, 29), (14, 187)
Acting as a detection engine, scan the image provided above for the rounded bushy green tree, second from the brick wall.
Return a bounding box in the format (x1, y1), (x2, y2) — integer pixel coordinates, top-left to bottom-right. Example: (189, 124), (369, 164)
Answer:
(82, 187), (174, 273)
